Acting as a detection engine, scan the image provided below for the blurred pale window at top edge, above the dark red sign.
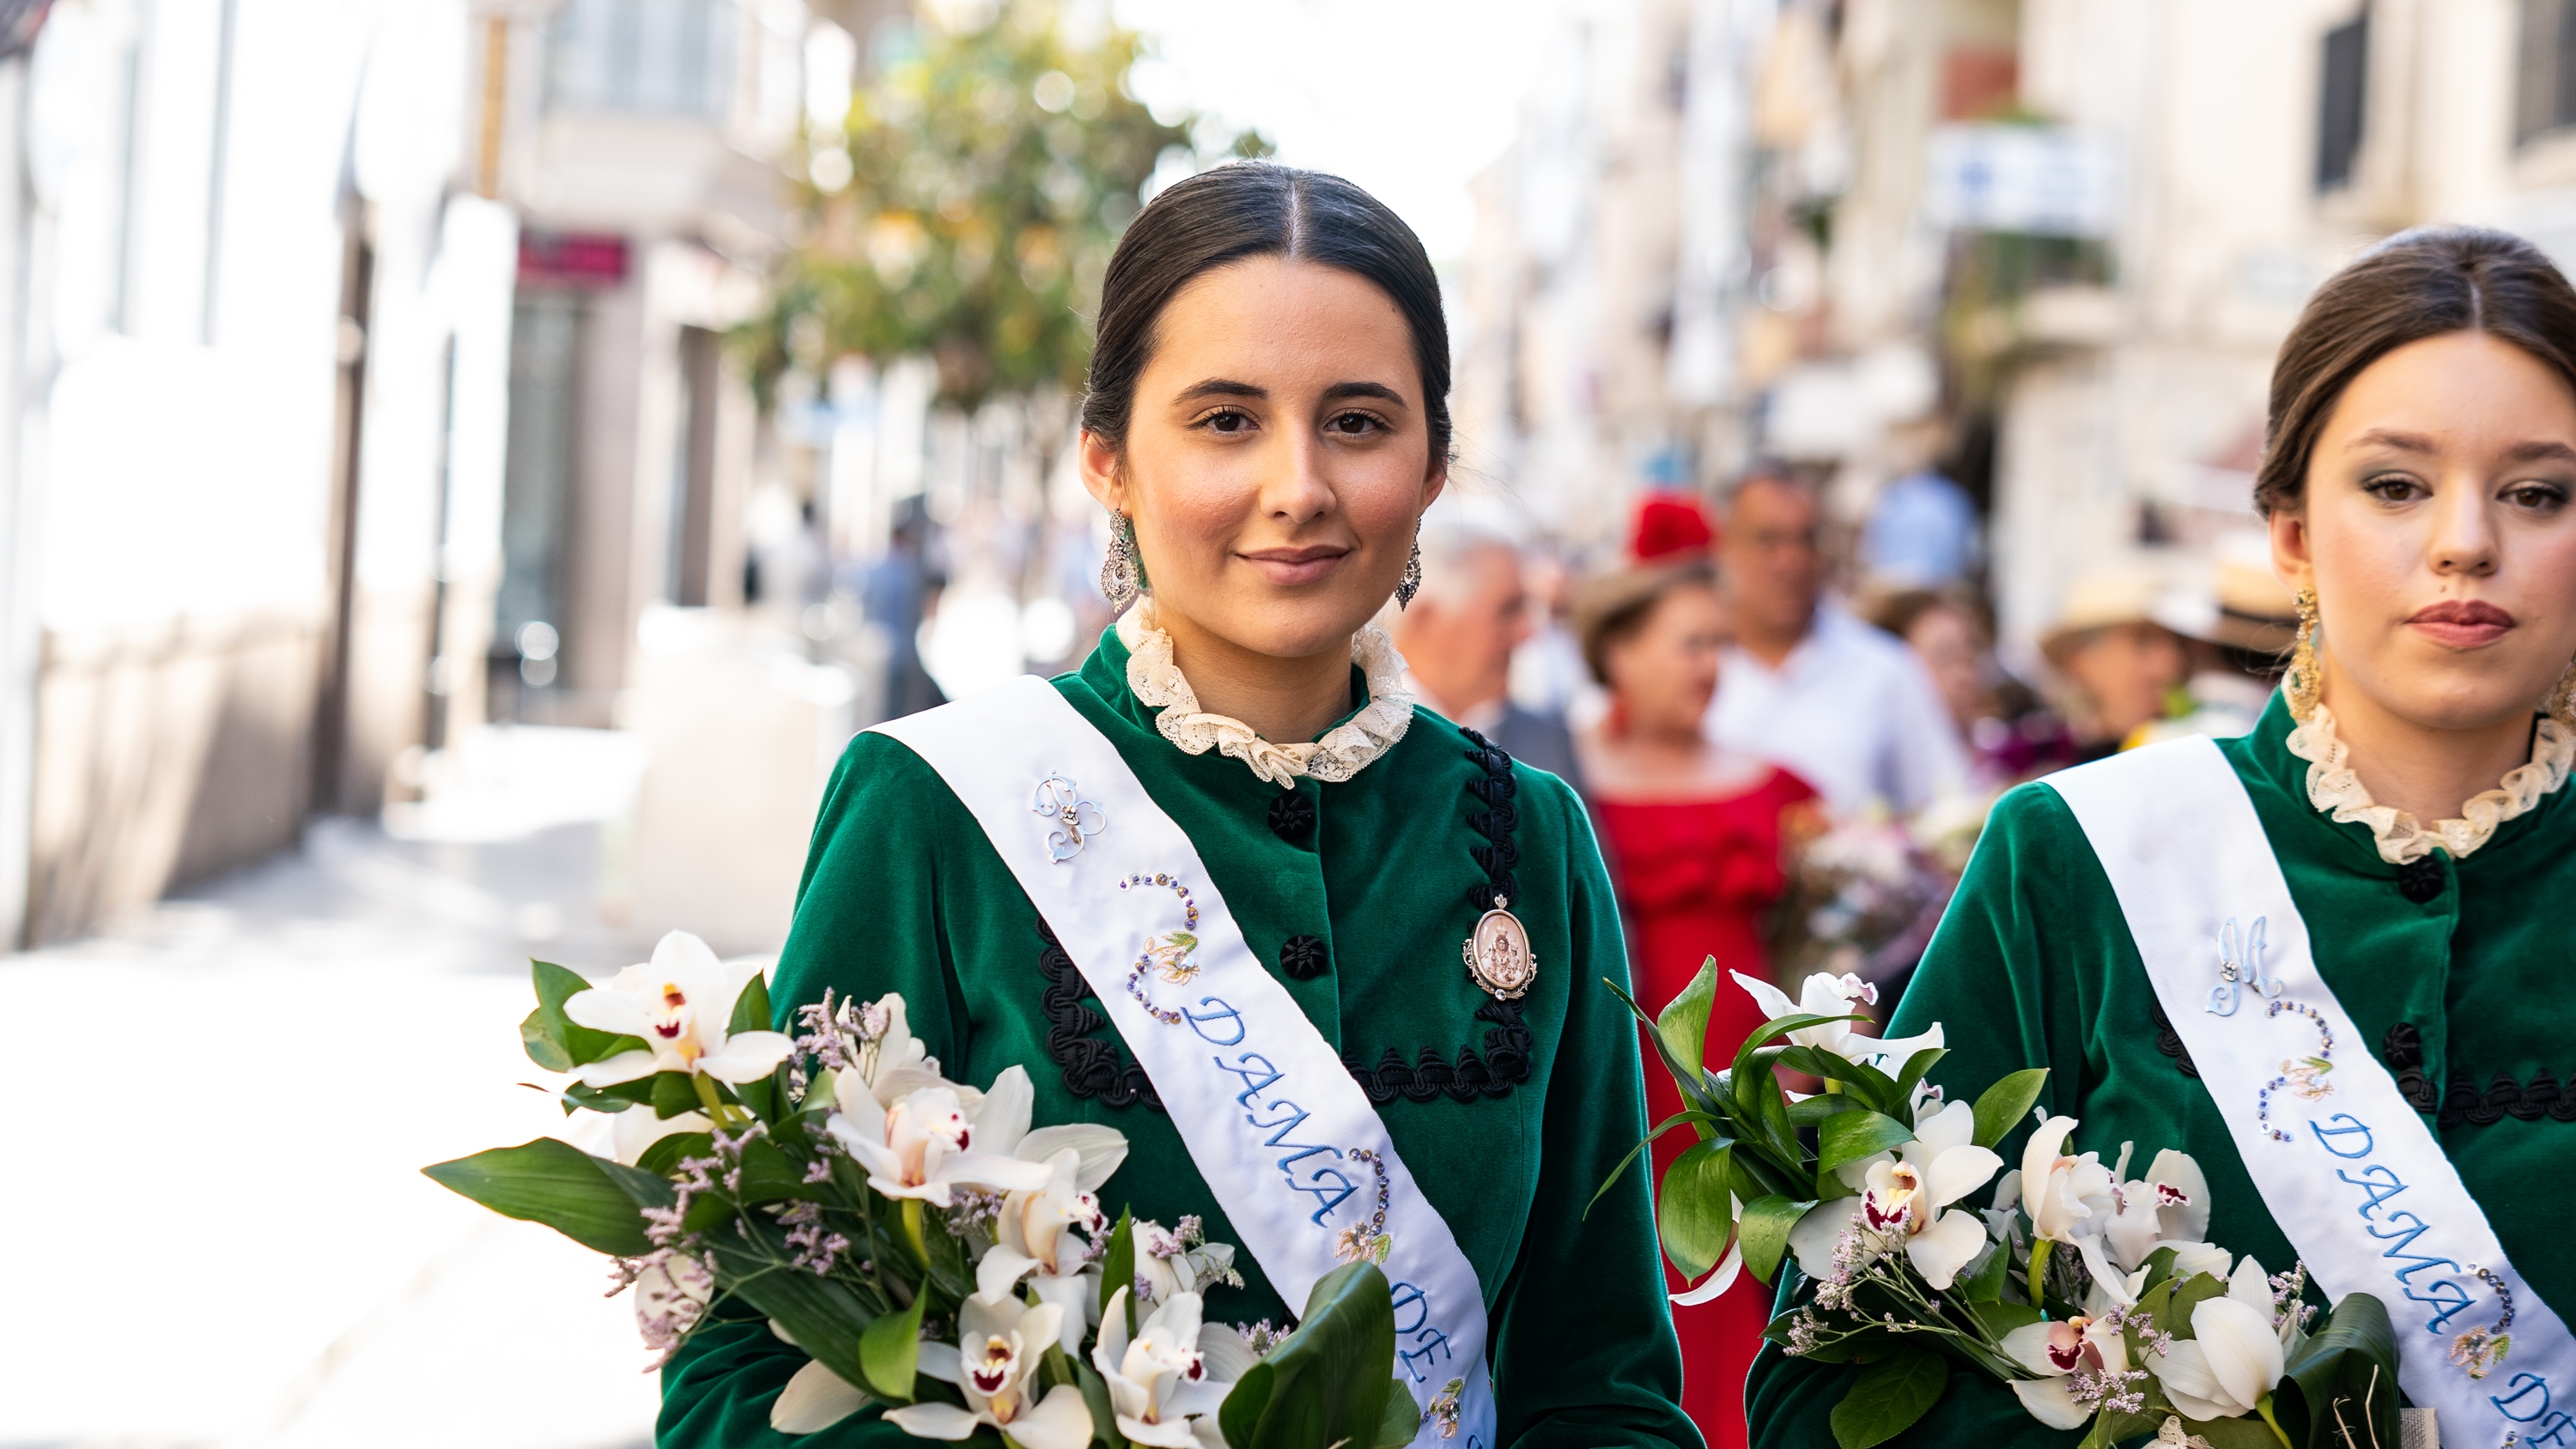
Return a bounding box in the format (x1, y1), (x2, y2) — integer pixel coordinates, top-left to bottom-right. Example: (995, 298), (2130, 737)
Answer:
(546, 0), (742, 121)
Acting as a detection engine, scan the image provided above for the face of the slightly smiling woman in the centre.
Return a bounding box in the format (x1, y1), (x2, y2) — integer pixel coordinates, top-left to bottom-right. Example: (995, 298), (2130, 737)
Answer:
(1082, 258), (1448, 659)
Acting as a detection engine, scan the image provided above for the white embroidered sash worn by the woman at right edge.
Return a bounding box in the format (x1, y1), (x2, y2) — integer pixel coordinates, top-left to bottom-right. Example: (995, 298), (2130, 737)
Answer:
(2045, 738), (2576, 1449)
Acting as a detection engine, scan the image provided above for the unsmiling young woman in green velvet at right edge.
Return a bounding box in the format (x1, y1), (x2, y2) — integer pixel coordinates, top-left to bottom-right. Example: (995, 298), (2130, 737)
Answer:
(1747, 229), (2576, 1449)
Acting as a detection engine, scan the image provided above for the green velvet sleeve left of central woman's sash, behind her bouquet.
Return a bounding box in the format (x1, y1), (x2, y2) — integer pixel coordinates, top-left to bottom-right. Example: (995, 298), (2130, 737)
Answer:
(654, 733), (981, 1449)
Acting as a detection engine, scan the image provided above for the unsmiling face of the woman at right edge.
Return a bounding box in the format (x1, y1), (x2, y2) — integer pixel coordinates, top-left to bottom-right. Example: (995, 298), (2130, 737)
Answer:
(2272, 332), (2576, 731)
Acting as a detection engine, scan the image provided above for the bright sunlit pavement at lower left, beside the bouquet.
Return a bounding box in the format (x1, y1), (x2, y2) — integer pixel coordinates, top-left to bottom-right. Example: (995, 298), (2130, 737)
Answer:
(0, 731), (685, 1449)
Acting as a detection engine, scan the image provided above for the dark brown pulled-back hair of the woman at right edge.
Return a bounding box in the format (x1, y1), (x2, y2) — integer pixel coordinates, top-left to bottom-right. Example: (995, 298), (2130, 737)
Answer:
(2254, 227), (2576, 518)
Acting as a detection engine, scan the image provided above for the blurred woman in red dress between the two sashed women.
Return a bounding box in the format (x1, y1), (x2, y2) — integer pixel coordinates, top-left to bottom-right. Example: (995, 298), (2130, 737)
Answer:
(1577, 564), (1816, 1449)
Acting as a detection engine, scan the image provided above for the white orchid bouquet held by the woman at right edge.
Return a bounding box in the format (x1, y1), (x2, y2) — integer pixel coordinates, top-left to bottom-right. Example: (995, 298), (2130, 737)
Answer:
(1602, 960), (2398, 1449)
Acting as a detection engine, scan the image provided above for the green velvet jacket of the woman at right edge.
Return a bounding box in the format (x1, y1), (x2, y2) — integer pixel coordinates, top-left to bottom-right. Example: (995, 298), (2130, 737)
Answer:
(1747, 695), (2576, 1449)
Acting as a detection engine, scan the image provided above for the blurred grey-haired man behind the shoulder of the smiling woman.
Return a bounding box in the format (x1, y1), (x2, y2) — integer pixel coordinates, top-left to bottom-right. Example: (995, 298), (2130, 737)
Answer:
(1394, 515), (1584, 792)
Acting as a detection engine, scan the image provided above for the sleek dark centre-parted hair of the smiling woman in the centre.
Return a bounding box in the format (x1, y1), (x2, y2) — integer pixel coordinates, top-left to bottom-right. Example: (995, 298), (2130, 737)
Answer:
(1082, 162), (1450, 466)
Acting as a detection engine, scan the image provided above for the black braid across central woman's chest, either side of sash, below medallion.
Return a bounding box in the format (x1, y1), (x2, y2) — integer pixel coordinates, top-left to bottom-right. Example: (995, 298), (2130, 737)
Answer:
(1038, 919), (1533, 1112)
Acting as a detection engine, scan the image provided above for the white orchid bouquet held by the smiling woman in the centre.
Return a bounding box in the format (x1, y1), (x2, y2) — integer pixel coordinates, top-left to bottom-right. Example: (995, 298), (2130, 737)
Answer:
(422, 931), (1422, 1449)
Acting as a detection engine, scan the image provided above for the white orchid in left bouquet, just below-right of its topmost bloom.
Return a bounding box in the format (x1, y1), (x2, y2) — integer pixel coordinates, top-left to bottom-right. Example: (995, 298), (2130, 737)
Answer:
(824, 1065), (1051, 1207)
